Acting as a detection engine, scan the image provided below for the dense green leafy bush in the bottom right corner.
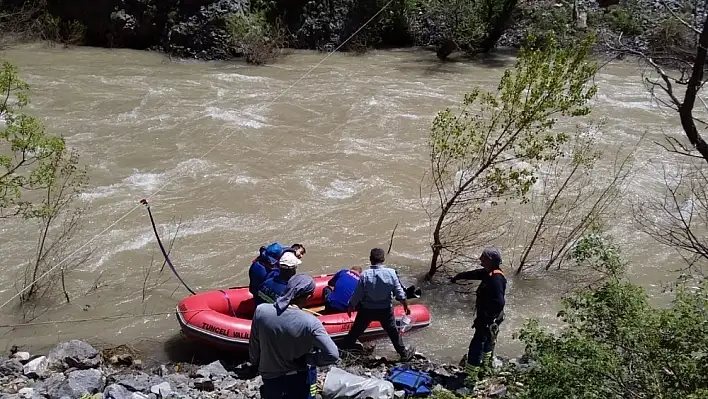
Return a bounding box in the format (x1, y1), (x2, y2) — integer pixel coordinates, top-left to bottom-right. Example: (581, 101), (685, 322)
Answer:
(514, 233), (708, 399)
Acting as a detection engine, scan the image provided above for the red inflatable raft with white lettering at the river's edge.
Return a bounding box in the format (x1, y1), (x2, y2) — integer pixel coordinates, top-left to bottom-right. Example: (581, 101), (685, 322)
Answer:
(177, 275), (430, 350)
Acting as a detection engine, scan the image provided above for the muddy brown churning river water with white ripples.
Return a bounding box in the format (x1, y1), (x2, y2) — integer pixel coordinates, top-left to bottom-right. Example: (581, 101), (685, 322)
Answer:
(0, 44), (692, 360)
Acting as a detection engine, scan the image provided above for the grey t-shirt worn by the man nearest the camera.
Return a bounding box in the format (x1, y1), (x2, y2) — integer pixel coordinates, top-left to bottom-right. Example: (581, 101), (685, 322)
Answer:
(248, 303), (339, 379)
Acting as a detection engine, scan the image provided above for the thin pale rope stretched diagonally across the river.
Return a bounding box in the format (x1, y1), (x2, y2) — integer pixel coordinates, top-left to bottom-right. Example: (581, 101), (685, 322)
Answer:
(0, 0), (393, 309)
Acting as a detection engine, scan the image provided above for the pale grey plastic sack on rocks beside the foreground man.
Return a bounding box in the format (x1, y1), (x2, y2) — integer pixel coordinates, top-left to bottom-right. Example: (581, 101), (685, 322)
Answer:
(322, 367), (395, 399)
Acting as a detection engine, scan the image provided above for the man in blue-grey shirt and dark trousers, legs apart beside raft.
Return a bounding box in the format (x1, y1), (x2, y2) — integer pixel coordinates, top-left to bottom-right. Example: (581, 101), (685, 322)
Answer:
(342, 248), (415, 361)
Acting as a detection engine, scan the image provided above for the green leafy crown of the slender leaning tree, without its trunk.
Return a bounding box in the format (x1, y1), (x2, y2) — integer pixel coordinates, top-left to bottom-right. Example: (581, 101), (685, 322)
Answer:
(430, 30), (597, 203)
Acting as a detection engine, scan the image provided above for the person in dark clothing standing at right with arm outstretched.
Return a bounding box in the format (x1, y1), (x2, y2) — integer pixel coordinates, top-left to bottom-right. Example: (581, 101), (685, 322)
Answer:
(450, 248), (506, 382)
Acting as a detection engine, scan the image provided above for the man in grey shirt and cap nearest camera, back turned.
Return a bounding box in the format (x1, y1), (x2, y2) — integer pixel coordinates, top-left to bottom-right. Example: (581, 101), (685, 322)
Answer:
(249, 274), (339, 399)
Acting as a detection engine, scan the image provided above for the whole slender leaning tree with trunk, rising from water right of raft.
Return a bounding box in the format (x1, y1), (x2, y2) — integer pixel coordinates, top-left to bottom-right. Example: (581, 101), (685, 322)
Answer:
(427, 33), (597, 278)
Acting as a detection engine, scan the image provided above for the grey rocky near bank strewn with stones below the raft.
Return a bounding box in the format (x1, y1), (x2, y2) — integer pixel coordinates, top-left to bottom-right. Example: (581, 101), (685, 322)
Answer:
(0, 340), (527, 399)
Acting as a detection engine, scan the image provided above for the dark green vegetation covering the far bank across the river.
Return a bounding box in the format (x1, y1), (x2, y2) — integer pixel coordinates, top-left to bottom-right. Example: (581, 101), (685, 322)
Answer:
(0, 0), (695, 64)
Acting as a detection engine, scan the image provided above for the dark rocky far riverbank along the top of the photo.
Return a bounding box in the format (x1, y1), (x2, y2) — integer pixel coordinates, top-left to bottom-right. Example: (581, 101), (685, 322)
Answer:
(0, 0), (705, 60)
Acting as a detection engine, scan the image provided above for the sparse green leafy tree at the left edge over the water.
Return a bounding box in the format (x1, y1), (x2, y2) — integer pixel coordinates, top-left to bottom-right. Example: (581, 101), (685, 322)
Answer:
(0, 62), (88, 318)
